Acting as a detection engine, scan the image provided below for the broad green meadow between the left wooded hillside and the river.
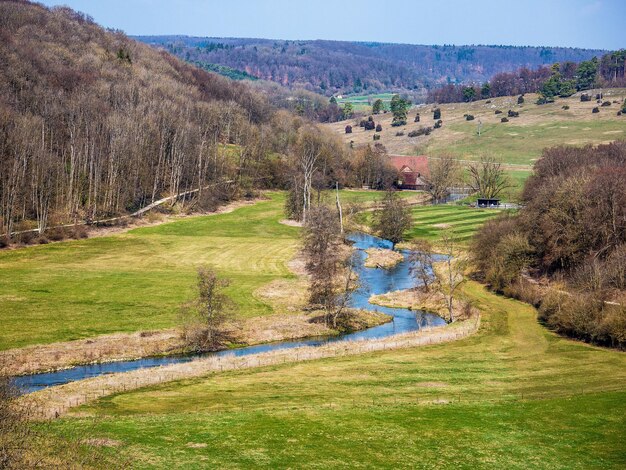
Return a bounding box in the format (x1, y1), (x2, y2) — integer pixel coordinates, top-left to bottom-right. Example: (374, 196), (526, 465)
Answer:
(0, 191), (411, 350)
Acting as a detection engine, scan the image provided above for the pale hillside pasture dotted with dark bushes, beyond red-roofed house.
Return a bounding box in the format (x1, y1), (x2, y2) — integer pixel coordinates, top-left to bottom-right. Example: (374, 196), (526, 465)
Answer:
(326, 89), (626, 165)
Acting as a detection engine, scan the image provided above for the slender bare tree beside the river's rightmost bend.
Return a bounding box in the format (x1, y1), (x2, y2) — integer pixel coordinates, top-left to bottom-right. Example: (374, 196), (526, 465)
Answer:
(437, 229), (467, 322)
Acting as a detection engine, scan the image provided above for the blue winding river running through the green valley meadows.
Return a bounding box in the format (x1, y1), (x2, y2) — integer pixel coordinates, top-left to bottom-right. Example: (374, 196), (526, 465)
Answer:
(14, 233), (445, 393)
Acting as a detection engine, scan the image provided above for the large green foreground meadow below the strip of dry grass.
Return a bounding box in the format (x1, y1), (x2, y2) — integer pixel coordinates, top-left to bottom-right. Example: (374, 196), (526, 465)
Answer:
(47, 282), (626, 469)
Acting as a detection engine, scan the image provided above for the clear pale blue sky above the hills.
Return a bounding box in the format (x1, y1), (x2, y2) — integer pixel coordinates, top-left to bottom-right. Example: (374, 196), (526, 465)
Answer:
(40, 0), (626, 49)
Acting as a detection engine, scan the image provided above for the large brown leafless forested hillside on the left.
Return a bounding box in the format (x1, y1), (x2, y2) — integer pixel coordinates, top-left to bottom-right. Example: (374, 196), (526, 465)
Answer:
(0, 1), (301, 239)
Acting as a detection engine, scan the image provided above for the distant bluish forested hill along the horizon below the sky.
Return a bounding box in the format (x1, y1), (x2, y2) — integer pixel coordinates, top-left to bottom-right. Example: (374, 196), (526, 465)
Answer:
(137, 36), (605, 95)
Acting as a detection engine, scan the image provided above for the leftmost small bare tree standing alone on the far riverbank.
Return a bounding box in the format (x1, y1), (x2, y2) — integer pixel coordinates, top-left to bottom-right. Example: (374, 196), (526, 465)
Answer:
(181, 266), (235, 351)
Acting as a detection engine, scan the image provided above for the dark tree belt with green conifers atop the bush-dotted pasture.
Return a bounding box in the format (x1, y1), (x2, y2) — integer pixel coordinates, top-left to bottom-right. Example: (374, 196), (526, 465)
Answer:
(428, 49), (626, 104)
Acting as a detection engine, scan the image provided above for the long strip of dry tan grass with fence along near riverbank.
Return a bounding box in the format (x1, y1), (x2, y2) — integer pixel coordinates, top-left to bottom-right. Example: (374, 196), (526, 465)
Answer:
(21, 315), (480, 419)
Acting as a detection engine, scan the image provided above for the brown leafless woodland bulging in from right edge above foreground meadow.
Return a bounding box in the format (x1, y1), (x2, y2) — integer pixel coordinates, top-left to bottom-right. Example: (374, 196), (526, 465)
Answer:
(473, 141), (626, 347)
